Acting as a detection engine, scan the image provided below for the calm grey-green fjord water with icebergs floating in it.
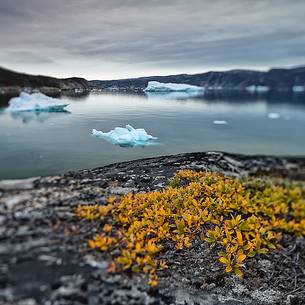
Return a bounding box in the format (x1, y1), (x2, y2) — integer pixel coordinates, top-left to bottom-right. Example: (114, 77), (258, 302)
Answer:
(0, 94), (305, 179)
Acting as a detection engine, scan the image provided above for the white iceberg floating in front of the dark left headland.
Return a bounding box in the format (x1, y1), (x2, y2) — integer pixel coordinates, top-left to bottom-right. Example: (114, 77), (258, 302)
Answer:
(6, 92), (69, 112)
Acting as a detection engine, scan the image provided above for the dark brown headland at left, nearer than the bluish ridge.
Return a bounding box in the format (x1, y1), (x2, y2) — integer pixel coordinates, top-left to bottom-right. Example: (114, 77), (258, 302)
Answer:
(0, 68), (89, 91)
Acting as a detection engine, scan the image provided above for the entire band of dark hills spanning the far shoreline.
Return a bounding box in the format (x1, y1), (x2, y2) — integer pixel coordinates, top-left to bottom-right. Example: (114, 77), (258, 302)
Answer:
(0, 67), (305, 93)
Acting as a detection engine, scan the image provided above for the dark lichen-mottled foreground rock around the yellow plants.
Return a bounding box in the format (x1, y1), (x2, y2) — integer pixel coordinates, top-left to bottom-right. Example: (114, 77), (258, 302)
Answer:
(0, 152), (305, 305)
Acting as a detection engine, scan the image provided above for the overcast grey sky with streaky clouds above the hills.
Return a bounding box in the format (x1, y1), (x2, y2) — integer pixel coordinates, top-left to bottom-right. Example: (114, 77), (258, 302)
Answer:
(0, 0), (305, 79)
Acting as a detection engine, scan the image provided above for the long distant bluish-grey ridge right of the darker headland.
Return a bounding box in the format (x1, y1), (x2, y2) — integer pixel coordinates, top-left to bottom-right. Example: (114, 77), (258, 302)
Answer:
(89, 67), (305, 92)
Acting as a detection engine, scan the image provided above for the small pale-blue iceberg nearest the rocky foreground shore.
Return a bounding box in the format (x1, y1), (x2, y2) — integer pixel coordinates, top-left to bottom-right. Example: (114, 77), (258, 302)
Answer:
(92, 125), (157, 147)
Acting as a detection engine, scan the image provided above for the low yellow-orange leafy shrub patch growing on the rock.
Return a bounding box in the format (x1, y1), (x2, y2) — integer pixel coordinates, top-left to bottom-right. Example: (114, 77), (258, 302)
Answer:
(76, 170), (305, 286)
